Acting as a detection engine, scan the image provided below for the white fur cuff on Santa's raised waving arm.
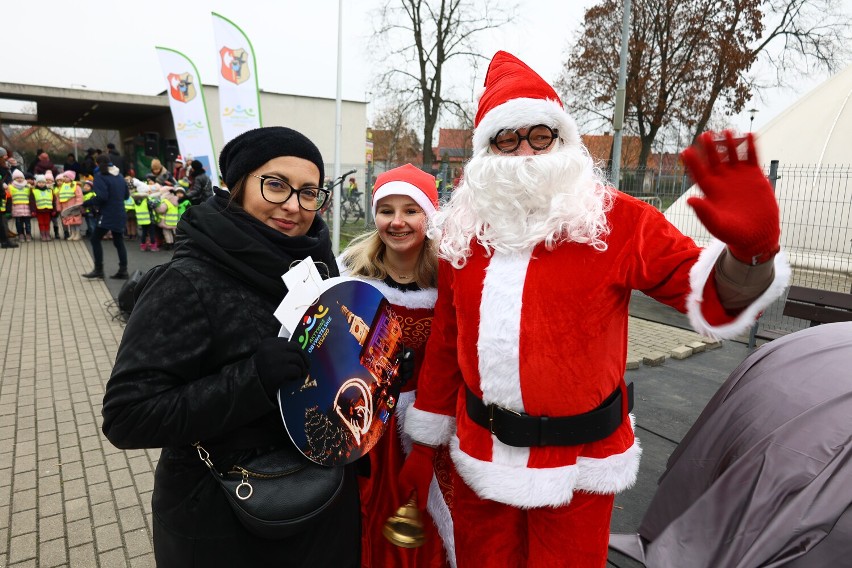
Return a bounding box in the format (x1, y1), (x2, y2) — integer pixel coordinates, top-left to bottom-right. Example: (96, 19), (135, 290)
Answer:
(686, 239), (791, 339)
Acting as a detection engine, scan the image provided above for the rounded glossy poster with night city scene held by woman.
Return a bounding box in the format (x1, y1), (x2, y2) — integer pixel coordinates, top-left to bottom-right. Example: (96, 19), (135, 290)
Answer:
(278, 278), (402, 466)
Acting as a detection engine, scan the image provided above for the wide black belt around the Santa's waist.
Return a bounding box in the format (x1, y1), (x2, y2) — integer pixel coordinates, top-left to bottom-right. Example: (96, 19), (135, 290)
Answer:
(466, 383), (633, 448)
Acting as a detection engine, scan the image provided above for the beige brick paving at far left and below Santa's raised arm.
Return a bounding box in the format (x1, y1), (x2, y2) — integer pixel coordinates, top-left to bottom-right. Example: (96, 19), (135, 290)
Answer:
(0, 232), (720, 568)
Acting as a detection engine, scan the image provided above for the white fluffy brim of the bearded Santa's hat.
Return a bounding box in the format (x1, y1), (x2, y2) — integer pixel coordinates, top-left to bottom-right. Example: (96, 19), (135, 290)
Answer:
(473, 98), (580, 152)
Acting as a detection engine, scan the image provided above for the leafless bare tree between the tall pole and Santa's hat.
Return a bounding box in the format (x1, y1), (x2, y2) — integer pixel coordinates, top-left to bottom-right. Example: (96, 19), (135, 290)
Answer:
(373, 0), (514, 170)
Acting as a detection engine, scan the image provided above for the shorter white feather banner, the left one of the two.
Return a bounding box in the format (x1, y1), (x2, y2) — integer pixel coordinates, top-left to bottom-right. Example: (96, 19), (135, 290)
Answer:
(156, 47), (219, 185)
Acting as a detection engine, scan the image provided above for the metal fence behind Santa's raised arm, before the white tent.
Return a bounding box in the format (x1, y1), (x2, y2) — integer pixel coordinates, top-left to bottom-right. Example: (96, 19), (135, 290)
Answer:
(621, 161), (852, 340)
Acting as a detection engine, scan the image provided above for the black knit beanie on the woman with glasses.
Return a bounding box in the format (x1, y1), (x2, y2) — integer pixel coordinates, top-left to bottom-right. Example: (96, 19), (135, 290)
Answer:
(219, 126), (325, 188)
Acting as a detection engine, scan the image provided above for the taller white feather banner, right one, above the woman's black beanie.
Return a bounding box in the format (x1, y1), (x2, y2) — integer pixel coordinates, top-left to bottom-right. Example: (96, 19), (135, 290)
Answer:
(212, 12), (261, 144)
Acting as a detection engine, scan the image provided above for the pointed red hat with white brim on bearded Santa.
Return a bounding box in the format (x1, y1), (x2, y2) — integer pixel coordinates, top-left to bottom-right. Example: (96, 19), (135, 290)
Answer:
(473, 51), (580, 152)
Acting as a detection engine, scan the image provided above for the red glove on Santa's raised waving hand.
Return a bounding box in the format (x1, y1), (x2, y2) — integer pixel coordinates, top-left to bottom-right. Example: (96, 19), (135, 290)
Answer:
(681, 130), (781, 266)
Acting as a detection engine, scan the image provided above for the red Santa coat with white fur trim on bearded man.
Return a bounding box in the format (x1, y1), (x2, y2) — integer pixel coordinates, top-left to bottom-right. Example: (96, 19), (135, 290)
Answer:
(406, 193), (789, 508)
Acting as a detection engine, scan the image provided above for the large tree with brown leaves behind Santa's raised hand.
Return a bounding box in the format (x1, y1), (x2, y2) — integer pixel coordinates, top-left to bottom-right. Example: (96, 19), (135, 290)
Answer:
(557, 0), (849, 173)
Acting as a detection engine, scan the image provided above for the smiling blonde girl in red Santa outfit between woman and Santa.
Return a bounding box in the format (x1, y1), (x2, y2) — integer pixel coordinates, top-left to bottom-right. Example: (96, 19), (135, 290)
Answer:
(340, 164), (454, 568)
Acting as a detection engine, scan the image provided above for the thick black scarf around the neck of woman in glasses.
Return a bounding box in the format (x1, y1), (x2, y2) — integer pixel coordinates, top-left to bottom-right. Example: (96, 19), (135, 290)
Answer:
(174, 188), (339, 299)
